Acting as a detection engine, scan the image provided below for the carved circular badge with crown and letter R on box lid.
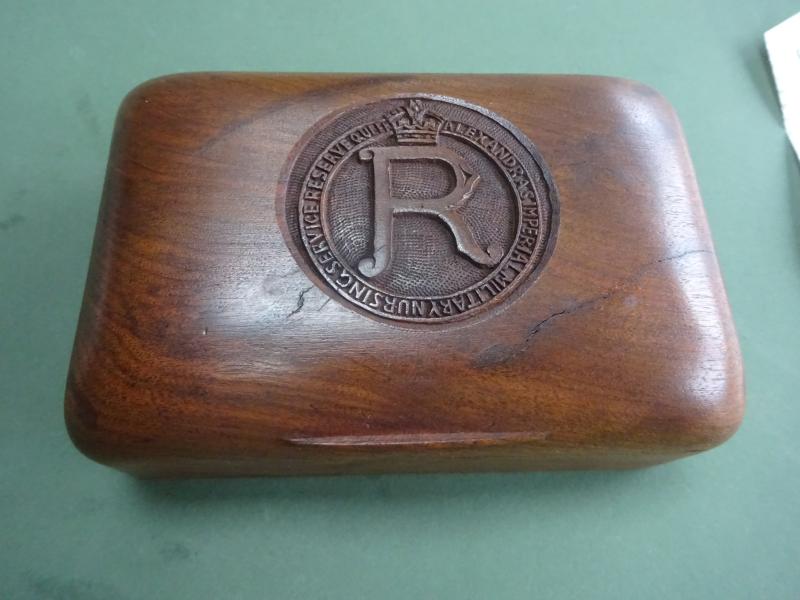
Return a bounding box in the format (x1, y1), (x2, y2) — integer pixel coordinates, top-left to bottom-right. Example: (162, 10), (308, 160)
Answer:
(279, 94), (558, 323)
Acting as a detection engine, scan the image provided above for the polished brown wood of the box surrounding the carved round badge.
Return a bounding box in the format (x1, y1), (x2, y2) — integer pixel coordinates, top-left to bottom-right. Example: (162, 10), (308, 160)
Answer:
(66, 74), (743, 476)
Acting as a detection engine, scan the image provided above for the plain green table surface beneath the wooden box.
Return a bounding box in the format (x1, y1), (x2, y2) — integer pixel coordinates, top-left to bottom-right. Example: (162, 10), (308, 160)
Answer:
(0, 0), (800, 600)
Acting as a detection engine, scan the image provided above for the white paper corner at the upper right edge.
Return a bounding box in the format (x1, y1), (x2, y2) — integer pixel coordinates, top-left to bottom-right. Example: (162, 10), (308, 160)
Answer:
(764, 13), (800, 160)
